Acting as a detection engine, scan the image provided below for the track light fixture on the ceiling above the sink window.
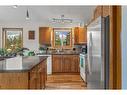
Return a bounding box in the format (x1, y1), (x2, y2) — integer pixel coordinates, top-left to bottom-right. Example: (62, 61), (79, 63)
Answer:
(52, 15), (73, 23)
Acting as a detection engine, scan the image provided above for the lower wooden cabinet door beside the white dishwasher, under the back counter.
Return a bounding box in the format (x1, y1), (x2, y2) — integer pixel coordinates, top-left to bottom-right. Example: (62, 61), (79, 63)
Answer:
(52, 55), (62, 73)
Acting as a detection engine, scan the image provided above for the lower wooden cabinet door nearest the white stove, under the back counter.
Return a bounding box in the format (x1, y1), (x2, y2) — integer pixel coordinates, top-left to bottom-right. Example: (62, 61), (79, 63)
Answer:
(71, 55), (80, 73)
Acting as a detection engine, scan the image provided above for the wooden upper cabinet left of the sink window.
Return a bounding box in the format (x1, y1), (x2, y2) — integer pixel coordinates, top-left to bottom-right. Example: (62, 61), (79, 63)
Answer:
(39, 27), (52, 45)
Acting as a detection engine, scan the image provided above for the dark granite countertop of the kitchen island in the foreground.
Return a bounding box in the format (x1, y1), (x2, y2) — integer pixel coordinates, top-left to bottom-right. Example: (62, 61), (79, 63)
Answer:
(0, 56), (47, 72)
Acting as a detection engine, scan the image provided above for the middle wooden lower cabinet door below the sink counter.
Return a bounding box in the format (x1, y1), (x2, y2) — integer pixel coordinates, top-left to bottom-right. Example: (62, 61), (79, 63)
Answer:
(61, 55), (73, 73)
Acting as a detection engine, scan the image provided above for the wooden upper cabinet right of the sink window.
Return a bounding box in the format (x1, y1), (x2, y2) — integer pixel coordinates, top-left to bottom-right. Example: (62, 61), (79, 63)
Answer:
(74, 27), (87, 44)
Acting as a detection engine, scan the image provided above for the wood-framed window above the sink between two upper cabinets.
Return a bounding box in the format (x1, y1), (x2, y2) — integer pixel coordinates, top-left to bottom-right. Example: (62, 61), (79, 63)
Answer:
(54, 28), (72, 47)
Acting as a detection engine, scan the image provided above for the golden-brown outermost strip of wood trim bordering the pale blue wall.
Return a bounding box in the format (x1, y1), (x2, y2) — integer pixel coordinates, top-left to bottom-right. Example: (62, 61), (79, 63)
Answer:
(117, 6), (122, 89)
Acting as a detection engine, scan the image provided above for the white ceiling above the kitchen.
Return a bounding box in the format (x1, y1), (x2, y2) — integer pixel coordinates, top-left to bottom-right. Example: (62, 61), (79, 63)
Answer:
(0, 6), (95, 24)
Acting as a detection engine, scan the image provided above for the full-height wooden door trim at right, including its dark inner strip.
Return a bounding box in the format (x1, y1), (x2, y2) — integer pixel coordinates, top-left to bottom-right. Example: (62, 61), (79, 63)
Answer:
(113, 6), (122, 89)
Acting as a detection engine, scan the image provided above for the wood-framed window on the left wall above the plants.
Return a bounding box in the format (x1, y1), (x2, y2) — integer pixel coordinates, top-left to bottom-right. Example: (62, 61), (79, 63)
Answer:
(2, 28), (23, 51)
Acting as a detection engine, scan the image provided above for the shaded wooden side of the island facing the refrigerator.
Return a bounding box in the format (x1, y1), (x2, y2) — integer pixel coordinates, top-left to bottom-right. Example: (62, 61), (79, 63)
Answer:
(29, 62), (47, 89)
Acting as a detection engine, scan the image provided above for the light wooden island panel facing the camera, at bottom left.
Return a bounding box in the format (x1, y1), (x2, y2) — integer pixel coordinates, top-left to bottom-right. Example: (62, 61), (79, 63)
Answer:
(0, 72), (29, 90)
